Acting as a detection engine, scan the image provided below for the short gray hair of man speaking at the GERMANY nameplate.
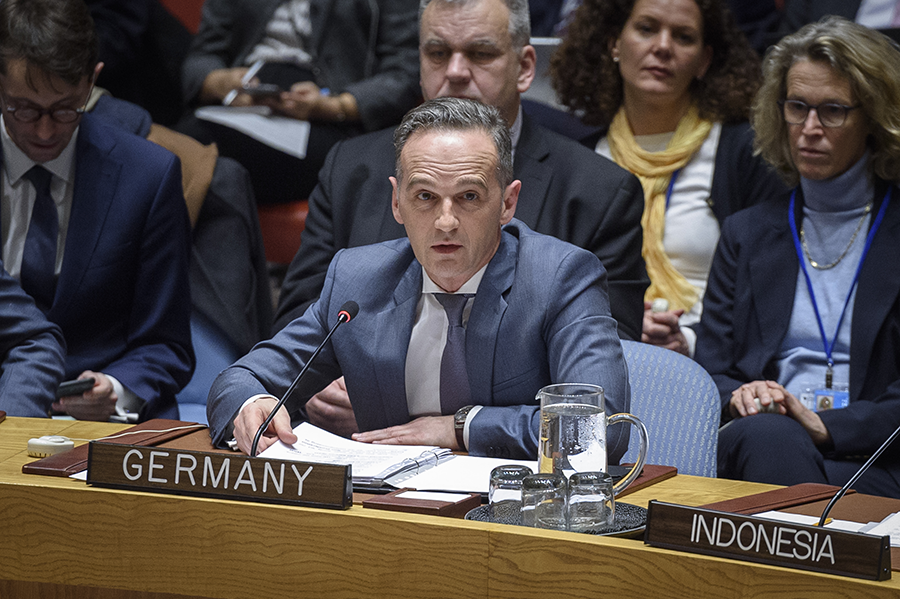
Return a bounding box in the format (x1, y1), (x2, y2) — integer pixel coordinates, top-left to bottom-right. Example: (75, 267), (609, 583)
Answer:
(394, 98), (513, 189)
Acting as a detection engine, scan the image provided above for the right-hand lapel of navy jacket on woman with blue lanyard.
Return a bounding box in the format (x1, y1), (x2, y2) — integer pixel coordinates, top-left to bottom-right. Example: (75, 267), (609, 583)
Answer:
(850, 187), (900, 401)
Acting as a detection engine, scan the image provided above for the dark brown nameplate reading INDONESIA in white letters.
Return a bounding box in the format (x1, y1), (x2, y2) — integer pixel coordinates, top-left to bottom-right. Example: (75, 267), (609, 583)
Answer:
(644, 501), (891, 580)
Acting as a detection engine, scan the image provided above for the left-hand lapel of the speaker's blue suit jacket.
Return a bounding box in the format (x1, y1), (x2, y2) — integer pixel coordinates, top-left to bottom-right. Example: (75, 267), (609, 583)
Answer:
(374, 260), (422, 426)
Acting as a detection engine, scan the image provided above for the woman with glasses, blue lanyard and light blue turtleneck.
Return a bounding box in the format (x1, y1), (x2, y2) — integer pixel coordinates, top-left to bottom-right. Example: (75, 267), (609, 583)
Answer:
(696, 17), (900, 497)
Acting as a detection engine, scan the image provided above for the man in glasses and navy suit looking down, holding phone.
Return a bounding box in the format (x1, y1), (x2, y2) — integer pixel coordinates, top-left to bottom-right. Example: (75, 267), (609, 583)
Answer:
(0, 0), (194, 420)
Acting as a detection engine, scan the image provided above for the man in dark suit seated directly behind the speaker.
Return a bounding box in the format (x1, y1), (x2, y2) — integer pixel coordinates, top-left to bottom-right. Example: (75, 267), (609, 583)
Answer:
(275, 0), (650, 435)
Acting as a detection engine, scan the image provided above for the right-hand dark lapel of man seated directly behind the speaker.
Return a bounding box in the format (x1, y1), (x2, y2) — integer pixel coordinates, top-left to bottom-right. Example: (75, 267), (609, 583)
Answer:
(513, 113), (554, 228)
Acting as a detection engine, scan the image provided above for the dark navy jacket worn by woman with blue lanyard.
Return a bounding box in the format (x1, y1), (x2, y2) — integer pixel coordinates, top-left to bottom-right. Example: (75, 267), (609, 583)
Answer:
(696, 185), (900, 476)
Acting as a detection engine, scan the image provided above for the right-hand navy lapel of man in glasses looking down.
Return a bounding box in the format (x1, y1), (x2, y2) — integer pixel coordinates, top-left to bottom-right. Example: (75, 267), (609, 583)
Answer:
(51, 115), (122, 322)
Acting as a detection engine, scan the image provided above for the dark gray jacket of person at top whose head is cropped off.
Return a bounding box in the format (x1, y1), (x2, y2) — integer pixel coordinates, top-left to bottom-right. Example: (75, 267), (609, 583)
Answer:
(182, 0), (419, 131)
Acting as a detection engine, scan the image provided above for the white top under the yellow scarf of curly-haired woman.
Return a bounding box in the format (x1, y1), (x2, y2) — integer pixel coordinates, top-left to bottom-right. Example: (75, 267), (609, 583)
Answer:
(596, 123), (722, 355)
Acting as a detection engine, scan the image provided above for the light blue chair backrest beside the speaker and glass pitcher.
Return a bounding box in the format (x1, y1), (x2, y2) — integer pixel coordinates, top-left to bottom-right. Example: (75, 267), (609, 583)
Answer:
(617, 341), (721, 477)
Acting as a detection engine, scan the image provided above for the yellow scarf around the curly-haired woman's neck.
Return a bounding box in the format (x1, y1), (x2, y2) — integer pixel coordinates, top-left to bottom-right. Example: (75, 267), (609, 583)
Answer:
(606, 105), (712, 310)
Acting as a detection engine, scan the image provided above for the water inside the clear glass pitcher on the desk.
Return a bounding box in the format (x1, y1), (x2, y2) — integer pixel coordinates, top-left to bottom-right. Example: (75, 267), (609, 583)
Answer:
(538, 403), (607, 478)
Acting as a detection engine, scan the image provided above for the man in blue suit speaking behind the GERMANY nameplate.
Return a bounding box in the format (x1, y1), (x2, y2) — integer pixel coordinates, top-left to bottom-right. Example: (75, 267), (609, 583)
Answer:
(207, 98), (629, 464)
